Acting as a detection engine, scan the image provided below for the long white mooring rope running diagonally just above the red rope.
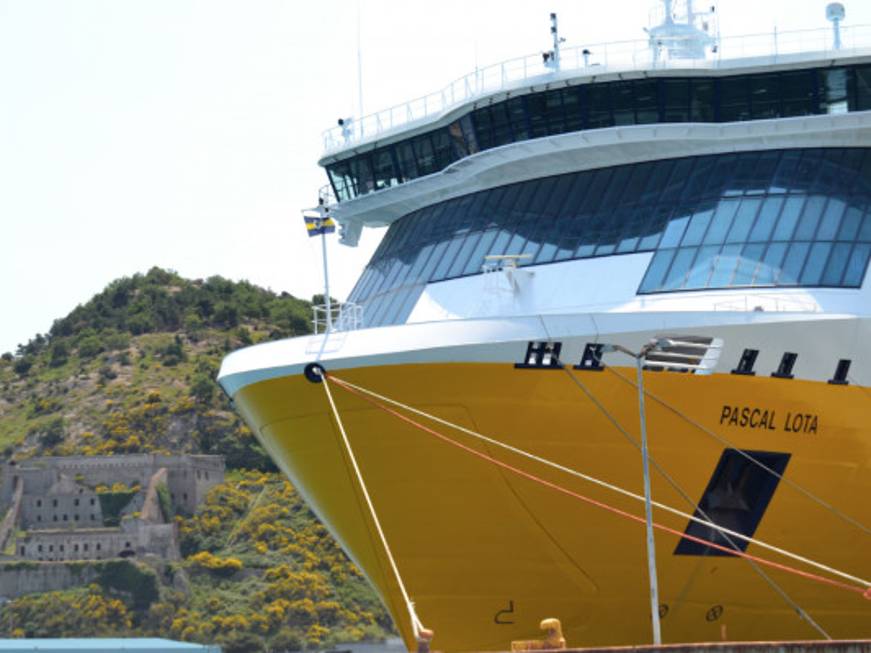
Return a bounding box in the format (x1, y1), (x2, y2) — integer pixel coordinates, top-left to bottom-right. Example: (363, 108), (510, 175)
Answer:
(328, 377), (871, 588)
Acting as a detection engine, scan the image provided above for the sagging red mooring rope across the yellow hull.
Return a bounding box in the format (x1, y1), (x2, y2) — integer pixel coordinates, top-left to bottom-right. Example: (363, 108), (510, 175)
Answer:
(329, 375), (871, 601)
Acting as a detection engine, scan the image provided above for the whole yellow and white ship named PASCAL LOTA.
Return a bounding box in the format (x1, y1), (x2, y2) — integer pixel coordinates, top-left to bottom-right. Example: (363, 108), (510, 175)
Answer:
(219, 2), (871, 652)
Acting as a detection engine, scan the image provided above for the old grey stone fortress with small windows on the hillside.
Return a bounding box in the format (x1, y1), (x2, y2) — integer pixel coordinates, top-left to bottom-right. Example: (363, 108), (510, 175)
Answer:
(0, 454), (224, 562)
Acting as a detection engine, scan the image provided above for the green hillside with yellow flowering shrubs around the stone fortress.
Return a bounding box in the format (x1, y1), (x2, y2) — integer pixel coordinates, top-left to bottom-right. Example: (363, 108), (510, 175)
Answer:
(0, 268), (392, 652)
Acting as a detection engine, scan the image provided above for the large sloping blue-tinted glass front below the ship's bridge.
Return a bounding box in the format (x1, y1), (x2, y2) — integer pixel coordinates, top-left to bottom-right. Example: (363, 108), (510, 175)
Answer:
(349, 148), (871, 326)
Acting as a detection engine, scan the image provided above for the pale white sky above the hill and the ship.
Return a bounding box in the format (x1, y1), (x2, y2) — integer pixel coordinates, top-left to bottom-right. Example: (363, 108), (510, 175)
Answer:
(0, 0), (871, 352)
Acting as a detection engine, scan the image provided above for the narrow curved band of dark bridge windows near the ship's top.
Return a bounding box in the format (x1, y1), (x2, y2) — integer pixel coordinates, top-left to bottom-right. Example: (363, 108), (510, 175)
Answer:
(327, 65), (871, 201)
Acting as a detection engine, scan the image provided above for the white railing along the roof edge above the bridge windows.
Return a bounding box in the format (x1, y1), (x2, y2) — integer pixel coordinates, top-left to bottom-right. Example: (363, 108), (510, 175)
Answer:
(323, 25), (871, 156)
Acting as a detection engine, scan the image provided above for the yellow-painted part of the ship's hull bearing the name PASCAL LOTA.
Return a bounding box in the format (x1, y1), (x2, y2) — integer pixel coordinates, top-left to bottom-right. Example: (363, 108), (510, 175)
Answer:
(235, 363), (871, 651)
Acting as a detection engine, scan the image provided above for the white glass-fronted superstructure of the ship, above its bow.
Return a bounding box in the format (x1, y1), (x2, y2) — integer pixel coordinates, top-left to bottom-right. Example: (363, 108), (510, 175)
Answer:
(321, 15), (871, 327)
